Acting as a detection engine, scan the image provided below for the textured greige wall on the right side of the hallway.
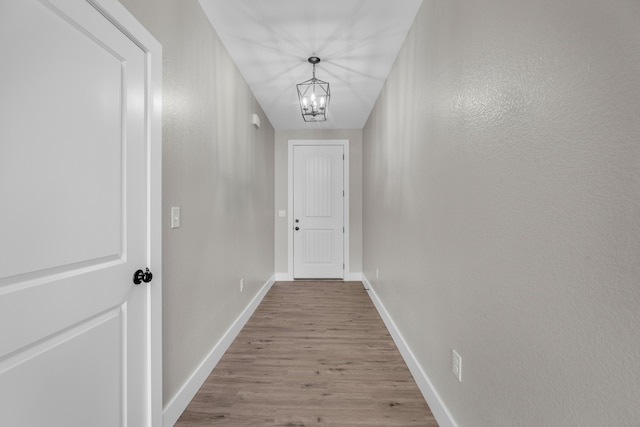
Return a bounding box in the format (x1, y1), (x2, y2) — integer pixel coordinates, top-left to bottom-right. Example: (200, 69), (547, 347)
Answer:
(363, 0), (640, 427)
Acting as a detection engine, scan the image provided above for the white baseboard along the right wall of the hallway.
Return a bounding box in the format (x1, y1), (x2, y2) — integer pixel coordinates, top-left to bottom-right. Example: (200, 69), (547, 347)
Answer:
(362, 274), (458, 427)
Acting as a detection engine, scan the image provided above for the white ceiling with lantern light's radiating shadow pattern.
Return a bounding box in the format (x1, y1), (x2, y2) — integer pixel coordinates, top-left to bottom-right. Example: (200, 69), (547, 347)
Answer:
(199, 0), (422, 129)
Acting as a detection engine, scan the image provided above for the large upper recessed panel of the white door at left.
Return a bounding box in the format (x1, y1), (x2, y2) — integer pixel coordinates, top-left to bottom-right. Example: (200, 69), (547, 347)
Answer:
(0, 1), (124, 276)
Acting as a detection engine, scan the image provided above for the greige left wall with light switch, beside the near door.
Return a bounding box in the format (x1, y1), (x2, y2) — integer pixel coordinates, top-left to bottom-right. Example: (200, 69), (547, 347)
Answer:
(123, 0), (274, 404)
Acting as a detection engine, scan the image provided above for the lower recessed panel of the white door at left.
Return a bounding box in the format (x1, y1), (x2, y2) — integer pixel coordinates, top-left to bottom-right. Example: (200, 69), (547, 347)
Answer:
(0, 310), (124, 426)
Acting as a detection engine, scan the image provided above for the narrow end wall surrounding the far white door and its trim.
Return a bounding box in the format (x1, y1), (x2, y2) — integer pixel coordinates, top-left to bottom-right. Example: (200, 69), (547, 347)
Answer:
(274, 130), (362, 274)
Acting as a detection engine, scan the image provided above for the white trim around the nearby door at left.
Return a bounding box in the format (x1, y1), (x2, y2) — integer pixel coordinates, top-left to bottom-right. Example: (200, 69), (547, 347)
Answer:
(86, 0), (163, 427)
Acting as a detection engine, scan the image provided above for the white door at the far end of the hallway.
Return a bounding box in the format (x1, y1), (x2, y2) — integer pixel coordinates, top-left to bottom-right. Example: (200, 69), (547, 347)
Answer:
(293, 145), (344, 279)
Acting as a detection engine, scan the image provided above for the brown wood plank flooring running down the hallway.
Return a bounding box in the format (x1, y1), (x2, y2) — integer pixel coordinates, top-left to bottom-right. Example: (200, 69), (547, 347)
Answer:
(176, 281), (438, 427)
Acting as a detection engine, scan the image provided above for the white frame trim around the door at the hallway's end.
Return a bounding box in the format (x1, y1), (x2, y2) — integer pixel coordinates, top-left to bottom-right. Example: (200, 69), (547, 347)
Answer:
(286, 139), (351, 280)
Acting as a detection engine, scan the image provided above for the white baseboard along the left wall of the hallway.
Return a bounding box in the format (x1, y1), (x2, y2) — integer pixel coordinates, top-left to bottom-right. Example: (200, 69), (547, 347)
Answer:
(163, 276), (275, 427)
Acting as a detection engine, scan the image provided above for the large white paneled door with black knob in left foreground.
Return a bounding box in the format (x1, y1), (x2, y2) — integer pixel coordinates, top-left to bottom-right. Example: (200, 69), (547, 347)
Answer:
(0, 0), (159, 427)
